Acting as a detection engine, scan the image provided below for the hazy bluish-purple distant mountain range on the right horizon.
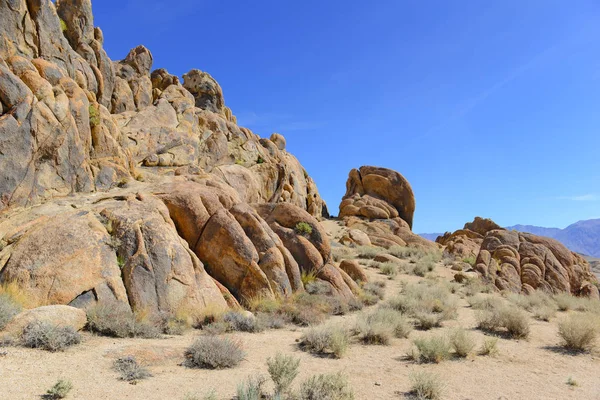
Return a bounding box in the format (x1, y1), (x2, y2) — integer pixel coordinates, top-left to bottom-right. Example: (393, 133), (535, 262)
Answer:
(420, 219), (600, 257)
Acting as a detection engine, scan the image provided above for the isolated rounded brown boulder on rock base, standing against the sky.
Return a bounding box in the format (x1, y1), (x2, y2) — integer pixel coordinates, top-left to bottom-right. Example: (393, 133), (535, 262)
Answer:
(339, 166), (437, 249)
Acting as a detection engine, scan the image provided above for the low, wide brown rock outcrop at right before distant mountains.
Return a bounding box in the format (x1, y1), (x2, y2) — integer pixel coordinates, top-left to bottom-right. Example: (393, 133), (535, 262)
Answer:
(437, 217), (599, 298)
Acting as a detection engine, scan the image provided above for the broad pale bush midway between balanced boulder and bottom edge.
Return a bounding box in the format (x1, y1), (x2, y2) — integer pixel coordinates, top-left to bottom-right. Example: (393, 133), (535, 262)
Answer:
(388, 282), (458, 330)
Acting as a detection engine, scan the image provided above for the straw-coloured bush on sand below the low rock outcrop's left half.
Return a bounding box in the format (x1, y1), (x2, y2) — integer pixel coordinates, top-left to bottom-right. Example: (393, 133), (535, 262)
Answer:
(476, 306), (529, 338)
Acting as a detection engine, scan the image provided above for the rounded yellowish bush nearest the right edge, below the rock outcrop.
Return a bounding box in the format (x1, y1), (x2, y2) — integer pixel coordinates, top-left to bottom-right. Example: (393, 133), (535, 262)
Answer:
(558, 314), (600, 351)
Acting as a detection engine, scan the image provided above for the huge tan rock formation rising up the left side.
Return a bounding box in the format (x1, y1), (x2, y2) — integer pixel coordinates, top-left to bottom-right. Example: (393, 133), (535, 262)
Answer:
(0, 0), (346, 318)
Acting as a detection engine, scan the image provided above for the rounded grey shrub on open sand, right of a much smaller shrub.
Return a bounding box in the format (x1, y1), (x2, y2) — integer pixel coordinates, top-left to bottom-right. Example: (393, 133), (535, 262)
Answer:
(184, 336), (246, 369)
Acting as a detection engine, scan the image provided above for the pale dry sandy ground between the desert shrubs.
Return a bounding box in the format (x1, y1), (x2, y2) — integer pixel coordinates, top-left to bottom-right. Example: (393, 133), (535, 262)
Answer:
(0, 226), (600, 400)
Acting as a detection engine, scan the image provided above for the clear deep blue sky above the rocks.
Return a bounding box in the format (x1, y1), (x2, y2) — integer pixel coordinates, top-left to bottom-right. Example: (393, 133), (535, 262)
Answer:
(94, 0), (600, 232)
